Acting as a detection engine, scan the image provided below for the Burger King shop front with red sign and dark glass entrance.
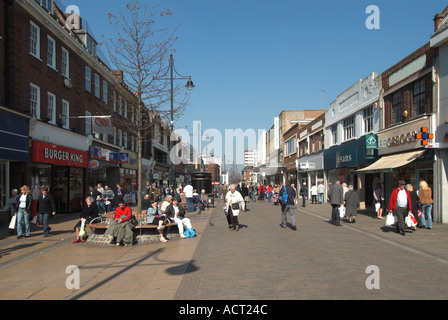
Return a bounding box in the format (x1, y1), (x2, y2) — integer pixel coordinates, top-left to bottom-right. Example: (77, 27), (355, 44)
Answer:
(31, 140), (88, 213)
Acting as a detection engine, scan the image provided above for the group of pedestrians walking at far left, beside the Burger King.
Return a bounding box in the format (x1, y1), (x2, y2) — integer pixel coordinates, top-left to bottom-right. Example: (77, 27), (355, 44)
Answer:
(5, 185), (56, 239)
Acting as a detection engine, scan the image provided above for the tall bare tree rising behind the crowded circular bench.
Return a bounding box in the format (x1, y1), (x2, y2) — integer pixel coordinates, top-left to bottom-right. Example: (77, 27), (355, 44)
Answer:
(105, 0), (189, 212)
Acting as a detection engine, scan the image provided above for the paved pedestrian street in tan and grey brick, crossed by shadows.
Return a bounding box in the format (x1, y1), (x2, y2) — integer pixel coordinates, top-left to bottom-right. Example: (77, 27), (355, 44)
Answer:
(0, 201), (448, 301)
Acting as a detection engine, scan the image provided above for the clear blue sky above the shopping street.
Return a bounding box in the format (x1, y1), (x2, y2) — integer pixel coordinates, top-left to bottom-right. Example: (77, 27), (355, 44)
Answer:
(62, 0), (448, 162)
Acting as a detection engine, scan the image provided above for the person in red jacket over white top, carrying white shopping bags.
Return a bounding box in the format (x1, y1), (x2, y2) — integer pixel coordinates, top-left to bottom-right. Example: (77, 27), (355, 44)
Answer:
(389, 180), (412, 236)
